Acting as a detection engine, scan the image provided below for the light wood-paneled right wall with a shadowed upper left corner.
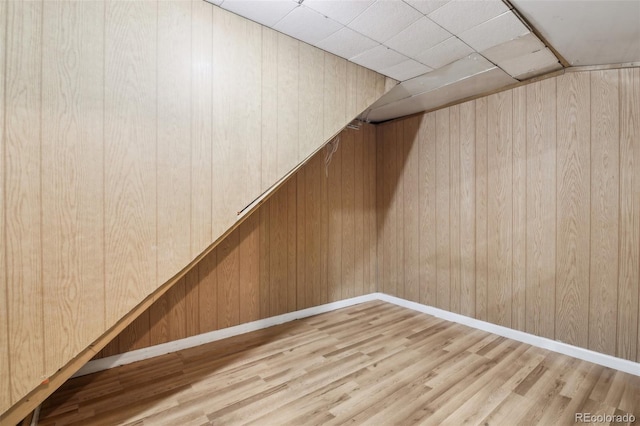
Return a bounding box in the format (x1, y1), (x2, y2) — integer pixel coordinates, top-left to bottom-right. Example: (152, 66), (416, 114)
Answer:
(377, 68), (640, 361)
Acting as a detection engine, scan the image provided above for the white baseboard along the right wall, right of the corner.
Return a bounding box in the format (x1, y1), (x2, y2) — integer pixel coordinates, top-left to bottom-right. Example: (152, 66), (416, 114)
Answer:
(376, 293), (640, 376)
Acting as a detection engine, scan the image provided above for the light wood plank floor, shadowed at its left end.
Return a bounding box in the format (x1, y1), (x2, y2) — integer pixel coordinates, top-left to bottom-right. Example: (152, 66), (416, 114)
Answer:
(39, 301), (640, 425)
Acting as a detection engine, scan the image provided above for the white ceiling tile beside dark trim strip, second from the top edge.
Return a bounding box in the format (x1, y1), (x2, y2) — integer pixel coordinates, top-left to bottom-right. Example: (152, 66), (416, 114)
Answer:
(459, 11), (529, 52)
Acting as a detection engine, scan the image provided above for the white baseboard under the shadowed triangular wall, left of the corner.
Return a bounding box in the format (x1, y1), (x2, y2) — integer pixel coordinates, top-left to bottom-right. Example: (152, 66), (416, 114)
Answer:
(71, 293), (378, 378)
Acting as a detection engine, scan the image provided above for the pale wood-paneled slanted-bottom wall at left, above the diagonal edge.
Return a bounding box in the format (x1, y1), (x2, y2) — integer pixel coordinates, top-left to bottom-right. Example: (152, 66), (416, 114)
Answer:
(0, 0), (392, 413)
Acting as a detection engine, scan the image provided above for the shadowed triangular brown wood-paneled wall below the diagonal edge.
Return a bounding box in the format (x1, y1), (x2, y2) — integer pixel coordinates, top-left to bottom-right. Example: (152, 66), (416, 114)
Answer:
(97, 125), (377, 358)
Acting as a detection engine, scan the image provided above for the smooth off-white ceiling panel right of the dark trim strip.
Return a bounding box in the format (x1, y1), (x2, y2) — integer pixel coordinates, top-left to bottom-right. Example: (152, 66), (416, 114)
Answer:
(512, 0), (640, 65)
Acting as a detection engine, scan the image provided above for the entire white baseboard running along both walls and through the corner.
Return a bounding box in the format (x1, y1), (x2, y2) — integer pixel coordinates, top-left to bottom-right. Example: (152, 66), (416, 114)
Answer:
(72, 293), (640, 377)
